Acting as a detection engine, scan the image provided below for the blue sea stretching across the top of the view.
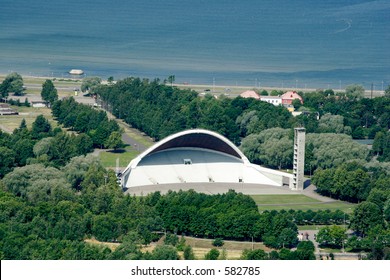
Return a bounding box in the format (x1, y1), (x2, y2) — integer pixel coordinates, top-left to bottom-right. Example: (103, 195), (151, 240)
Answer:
(0, 0), (390, 90)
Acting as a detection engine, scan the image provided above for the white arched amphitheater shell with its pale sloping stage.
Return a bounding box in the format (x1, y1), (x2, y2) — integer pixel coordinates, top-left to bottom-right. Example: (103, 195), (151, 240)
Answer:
(121, 129), (290, 193)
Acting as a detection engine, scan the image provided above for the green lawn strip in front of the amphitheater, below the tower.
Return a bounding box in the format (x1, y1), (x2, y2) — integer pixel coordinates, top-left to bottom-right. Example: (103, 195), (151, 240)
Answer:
(251, 194), (355, 213)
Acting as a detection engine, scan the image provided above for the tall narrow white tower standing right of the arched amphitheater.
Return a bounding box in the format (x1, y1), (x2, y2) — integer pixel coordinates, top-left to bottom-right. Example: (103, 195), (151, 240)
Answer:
(290, 127), (306, 191)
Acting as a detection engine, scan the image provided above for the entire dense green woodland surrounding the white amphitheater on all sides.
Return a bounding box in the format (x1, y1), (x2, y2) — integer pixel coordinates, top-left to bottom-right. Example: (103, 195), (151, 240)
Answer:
(0, 75), (390, 259)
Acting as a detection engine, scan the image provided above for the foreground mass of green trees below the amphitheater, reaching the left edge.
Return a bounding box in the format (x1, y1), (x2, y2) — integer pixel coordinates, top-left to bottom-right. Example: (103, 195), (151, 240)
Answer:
(0, 156), (308, 259)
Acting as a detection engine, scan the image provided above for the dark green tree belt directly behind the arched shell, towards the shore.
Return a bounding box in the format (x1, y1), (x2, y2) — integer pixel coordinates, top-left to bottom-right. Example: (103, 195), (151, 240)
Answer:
(94, 78), (292, 144)
